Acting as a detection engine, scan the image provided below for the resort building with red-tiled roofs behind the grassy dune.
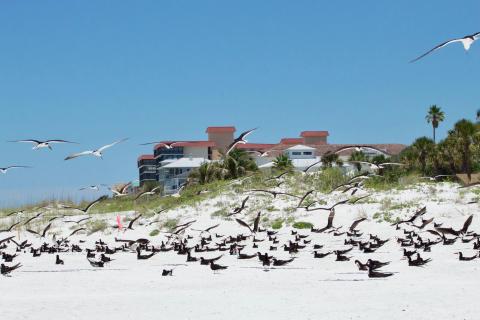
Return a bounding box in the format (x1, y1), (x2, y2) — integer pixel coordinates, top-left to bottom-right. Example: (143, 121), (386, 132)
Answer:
(137, 126), (406, 194)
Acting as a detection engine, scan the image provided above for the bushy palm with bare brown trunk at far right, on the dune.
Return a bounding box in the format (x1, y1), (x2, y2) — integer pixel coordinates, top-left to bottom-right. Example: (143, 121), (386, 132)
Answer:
(453, 119), (477, 179)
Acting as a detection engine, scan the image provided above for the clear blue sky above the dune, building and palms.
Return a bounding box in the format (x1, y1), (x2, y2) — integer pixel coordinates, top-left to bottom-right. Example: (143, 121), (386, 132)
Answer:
(0, 0), (480, 206)
